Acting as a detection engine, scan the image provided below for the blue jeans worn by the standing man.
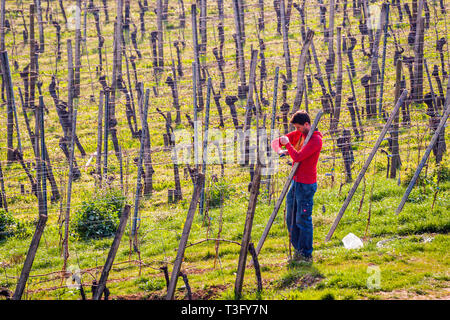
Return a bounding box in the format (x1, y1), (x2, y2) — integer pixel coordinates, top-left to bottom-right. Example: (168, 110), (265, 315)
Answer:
(286, 181), (317, 257)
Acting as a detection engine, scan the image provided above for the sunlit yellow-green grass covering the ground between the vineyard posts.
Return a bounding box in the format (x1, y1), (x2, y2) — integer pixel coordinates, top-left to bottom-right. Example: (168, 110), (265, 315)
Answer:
(0, 1), (450, 299)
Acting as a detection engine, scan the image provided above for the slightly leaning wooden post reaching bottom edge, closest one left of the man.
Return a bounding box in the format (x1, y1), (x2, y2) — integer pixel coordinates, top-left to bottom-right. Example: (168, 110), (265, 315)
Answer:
(234, 165), (261, 299)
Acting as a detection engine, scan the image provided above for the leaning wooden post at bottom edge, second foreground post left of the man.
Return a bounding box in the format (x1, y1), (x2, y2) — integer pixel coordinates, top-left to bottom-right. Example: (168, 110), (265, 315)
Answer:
(166, 172), (205, 300)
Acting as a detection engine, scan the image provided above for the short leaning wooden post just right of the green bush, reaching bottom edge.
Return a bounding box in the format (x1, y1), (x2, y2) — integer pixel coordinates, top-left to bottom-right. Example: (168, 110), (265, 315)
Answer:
(92, 204), (131, 300)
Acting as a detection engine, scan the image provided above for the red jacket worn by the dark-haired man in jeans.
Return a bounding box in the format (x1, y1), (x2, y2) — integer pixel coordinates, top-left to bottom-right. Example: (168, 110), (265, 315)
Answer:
(276, 130), (322, 184)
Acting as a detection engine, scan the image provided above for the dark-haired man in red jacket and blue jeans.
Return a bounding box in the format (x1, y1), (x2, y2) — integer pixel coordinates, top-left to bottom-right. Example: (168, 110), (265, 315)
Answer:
(272, 111), (322, 262)
